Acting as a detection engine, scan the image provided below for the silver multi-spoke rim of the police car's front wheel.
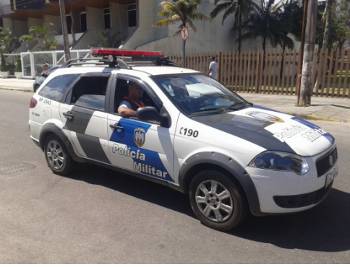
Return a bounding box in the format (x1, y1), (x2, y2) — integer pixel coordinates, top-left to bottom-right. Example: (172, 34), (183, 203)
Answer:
(195, 180), (234, 222)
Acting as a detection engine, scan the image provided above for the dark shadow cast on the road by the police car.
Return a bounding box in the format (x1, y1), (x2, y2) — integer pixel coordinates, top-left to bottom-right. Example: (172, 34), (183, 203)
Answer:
(70, 164), (350, 252)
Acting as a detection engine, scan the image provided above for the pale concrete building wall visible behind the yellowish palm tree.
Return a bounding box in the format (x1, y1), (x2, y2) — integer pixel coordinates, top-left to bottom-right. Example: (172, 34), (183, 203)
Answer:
(125, 0), (260, 55)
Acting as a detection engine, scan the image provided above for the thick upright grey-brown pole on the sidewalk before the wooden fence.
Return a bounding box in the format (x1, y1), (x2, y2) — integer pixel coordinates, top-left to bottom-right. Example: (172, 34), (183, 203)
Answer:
(299, 0), (317, 107)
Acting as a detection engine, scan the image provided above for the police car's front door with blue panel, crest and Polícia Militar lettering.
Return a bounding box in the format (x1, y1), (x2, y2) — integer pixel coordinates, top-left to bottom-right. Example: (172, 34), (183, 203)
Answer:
(108, 75), (175, 183)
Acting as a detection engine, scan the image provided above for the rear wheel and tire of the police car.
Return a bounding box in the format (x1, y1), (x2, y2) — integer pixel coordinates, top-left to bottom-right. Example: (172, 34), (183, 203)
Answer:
(44, 135), (74, 176)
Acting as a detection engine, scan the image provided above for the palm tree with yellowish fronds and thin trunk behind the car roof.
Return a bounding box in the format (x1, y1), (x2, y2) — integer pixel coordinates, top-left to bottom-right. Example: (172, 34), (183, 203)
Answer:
(156, 0), (207, 66)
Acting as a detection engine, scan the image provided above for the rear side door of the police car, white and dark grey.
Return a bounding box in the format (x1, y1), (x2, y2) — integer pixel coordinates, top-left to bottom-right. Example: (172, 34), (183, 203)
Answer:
(60, 73), (110, 164)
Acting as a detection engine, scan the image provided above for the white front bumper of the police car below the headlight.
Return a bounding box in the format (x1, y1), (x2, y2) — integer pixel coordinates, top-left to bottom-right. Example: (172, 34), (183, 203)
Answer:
(247, 146), (338, 213)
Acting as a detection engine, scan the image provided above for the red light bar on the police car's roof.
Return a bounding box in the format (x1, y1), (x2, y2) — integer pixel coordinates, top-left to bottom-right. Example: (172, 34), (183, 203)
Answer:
(91, 48), (164, 58)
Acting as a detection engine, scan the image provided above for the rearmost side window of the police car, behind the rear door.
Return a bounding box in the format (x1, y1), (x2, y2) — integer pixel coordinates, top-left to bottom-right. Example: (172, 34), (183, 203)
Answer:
(39, 74), (79, 102)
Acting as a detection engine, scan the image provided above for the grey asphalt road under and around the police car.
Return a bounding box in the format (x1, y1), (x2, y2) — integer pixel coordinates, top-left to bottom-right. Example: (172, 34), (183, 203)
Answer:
(0, 91), (350, 263)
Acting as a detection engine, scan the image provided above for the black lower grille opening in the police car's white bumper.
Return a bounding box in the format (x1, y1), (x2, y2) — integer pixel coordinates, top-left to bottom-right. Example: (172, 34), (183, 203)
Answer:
(273, 185), (332, 209)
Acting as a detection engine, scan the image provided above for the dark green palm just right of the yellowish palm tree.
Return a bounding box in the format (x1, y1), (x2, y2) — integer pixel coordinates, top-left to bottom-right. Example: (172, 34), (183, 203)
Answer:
(210, 0), (255, 53)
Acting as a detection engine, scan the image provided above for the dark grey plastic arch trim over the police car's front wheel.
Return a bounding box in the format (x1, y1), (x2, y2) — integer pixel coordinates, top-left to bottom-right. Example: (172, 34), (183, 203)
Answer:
(179, 152), (263, 216)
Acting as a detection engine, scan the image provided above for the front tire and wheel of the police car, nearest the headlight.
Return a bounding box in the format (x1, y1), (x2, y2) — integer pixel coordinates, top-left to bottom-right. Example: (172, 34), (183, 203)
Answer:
(189, 170), (248, 231)
